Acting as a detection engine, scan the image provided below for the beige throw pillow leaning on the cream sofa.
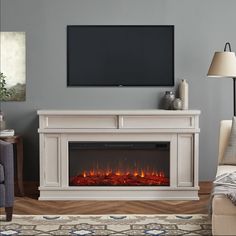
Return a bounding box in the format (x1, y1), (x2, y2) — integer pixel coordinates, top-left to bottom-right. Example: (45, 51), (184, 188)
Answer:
(221, 117), (236, 165)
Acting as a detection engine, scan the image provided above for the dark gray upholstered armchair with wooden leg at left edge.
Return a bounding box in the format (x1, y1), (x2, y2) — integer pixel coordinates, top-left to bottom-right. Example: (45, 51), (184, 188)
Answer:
(0, 140), (14, 221)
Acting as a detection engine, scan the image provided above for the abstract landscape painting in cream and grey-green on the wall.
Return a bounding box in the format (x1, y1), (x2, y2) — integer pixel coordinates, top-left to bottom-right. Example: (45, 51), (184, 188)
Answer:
(0, 32), (26, 101)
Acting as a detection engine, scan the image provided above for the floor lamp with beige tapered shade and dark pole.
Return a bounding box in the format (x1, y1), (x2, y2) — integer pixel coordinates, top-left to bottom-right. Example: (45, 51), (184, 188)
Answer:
(207, 43), (236, 116)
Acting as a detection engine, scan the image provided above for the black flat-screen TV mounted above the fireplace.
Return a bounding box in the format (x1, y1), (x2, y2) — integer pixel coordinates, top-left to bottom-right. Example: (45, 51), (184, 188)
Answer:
(67, 25), (174, 86)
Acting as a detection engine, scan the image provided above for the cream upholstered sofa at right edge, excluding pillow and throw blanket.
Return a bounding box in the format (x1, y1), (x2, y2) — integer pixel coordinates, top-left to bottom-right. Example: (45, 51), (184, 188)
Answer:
(212, 120), (236, 235)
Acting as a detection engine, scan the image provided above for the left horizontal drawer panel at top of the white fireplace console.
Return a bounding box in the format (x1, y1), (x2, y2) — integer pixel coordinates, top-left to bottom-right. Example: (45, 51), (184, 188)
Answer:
(45, 116), (117, 129)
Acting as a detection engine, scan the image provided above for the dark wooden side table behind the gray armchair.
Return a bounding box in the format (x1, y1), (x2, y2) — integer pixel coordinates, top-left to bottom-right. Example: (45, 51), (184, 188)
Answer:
(0, 135), (24, 197)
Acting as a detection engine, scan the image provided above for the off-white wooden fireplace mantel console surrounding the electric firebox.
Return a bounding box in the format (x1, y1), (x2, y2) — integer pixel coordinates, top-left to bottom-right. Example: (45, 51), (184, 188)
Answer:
(38, 110), (200, 200)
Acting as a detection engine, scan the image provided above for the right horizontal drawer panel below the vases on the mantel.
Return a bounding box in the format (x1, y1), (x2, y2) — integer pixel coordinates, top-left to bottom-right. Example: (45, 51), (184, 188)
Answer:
(120, 116), (194, 129)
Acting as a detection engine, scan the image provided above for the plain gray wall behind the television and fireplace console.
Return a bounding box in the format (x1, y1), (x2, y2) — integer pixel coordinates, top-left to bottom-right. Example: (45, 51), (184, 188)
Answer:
(1, 0), (236, 180)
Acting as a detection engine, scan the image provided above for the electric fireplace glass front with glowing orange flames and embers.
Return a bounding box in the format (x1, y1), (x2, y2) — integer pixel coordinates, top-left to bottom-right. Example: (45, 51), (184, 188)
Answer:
(68, 142), (170, 186)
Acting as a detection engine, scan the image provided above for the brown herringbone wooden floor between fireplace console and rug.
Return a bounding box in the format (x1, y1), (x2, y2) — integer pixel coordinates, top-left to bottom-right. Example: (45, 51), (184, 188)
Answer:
(0, 182), (212, 215)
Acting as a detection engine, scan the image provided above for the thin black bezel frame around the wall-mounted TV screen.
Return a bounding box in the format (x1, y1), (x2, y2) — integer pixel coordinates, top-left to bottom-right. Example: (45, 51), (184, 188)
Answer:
(66, 25), (175, 87)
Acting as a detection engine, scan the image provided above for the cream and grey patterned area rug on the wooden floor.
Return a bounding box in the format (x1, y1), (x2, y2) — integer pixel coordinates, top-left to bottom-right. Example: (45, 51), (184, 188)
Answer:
(0, 215), (211, 236)
